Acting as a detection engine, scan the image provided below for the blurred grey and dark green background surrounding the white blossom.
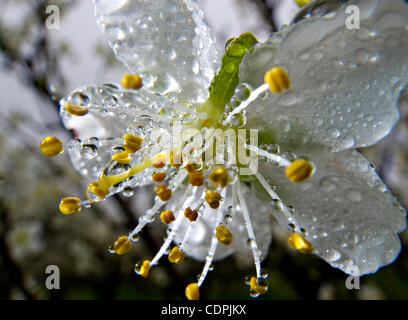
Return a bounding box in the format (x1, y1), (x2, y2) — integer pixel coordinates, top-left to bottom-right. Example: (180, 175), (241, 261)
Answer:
(0, 0), (408, 299)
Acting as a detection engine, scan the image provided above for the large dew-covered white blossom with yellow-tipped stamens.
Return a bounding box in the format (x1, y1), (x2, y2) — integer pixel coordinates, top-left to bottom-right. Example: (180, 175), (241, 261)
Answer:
(41, 0), (408, 299)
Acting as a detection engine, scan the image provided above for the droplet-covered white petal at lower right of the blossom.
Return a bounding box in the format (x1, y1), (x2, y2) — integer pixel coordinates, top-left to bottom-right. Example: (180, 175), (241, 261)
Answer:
(260, 150), (406, 275)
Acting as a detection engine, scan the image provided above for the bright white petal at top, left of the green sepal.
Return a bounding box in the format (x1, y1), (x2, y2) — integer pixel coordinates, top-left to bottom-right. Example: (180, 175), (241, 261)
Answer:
(94, 0), (219, 100)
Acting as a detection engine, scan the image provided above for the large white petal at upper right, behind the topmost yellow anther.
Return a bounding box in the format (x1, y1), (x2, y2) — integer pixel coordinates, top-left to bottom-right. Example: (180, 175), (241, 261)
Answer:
(240, 0), (408, 151)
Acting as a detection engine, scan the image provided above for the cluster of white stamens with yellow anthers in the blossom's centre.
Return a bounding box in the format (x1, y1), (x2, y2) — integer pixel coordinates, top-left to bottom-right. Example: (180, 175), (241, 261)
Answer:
(40, 68), (315, 300)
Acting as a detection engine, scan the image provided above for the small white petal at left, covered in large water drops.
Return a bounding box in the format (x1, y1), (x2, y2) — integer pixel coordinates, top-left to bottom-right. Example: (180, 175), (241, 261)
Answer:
(60, 84), (172, 181)
